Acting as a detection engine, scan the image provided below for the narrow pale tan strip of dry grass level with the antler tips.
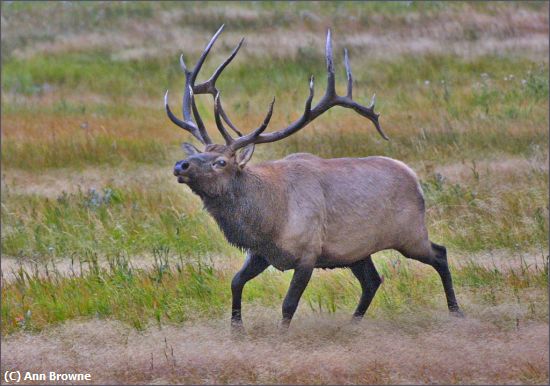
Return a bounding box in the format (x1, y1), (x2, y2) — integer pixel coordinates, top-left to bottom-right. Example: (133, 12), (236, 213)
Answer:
(9, 28), (548, 62)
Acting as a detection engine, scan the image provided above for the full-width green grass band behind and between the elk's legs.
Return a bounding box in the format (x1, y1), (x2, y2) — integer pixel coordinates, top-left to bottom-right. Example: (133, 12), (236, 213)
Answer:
(2, 247), (548, 334)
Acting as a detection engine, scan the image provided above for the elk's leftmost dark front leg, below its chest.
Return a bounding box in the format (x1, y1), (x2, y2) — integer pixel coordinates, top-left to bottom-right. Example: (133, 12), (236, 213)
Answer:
(231, 252), (269, 327)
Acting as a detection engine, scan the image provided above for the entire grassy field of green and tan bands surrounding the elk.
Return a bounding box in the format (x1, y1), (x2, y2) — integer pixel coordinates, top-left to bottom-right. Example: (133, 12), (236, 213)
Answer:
(1, 2), (549, 384)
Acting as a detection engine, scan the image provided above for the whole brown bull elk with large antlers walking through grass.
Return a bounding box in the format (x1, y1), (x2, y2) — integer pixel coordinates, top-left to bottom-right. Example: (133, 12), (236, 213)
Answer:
(165, 25), (461, 326)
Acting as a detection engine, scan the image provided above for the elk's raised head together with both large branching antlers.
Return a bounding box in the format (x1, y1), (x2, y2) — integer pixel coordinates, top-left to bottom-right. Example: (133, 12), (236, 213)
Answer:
(168, 25), (388, 196)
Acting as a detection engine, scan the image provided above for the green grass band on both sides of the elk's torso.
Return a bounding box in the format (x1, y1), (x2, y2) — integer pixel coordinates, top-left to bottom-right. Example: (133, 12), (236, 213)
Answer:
(1, 154), (548, 258)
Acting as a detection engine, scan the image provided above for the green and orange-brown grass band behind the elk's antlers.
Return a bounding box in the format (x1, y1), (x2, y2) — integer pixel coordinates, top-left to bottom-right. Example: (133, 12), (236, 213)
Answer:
(2, 53), (548, 169)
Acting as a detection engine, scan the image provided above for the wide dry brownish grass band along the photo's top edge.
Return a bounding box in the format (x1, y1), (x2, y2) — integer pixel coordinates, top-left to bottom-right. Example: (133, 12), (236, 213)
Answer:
(2, 3), (548, 60)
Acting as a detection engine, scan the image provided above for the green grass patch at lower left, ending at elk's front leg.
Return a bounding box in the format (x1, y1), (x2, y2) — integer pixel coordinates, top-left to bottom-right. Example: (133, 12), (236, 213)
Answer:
(2, 254), (227, 333)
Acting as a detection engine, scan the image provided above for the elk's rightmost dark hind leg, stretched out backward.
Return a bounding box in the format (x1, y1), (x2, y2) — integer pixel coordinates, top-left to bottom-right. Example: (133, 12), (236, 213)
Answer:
(400, 239), (464, 316)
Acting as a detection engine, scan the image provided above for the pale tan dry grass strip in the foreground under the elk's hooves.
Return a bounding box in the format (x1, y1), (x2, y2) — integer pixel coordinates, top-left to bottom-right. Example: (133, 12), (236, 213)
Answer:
(1, 309), (549, 384)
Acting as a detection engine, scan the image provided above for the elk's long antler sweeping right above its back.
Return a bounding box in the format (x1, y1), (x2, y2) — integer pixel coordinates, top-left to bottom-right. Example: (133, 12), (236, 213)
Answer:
(231, 29), (388, 150)
